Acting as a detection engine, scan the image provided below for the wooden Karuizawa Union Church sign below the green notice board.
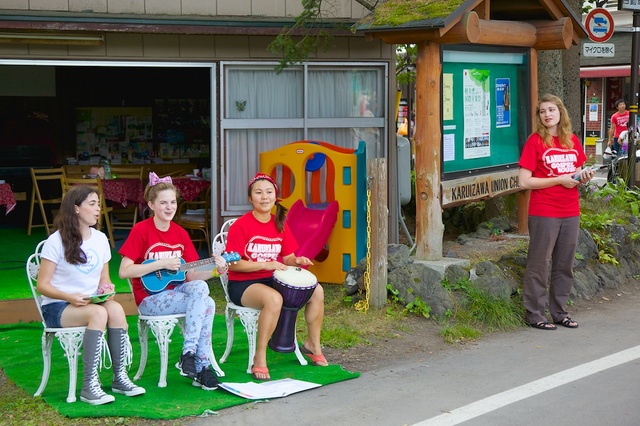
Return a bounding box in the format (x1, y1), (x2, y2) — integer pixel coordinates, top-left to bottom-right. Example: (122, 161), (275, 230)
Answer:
(442, 171), (520, 207)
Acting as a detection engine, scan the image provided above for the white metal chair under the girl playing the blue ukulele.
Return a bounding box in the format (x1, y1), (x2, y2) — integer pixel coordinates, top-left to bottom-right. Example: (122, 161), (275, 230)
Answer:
(127, 280), (224, 388)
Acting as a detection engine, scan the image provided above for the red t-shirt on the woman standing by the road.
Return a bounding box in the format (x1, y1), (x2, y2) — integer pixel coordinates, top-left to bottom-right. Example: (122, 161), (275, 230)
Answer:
(518, 133), (587, 218)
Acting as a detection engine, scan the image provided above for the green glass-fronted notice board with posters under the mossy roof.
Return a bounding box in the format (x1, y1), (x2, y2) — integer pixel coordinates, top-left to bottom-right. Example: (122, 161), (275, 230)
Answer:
(441, 47), (531, 180)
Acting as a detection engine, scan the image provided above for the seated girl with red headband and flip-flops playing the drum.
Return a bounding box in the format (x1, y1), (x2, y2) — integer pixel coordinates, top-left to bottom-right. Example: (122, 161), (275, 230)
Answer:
(226, 173), (329, 380)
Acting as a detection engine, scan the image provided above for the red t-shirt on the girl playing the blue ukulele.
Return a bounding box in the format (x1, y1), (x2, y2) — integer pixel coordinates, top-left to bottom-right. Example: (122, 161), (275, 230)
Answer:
(118, 217), (199, 305)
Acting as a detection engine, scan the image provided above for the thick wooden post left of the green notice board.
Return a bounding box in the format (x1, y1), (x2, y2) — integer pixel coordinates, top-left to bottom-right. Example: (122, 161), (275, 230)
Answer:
(414, 42), (444, 260)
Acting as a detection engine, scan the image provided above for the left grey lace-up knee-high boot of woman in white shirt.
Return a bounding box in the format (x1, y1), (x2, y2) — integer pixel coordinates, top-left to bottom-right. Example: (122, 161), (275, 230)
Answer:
(80, 329), (115, 405)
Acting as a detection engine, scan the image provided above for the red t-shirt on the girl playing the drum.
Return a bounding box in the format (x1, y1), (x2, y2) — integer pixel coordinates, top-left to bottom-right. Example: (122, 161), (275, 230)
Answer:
(226, 212), (298, 281)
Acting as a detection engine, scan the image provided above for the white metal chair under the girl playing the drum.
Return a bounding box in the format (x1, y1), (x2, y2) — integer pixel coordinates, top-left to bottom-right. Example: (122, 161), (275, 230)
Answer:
(213, 219), (307, 374)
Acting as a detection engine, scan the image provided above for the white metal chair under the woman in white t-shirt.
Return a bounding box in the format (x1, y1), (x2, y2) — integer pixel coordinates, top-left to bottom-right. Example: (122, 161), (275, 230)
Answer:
(26, 241), (86, 402)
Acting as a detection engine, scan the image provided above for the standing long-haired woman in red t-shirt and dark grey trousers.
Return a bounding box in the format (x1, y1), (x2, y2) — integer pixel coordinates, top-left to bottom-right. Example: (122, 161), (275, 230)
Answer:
(518, 94), (595, 330)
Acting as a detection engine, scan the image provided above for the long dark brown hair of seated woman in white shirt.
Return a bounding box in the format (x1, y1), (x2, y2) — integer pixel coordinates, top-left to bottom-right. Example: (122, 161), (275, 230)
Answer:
(54, 185), (98, 265)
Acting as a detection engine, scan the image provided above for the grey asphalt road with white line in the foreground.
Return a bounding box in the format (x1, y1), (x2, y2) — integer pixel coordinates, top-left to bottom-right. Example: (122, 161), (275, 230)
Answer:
(189, 284), (640, 426)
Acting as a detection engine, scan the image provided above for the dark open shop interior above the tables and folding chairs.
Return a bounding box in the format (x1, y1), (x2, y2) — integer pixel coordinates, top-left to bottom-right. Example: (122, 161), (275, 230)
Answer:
(0, 65), (211, 226)
